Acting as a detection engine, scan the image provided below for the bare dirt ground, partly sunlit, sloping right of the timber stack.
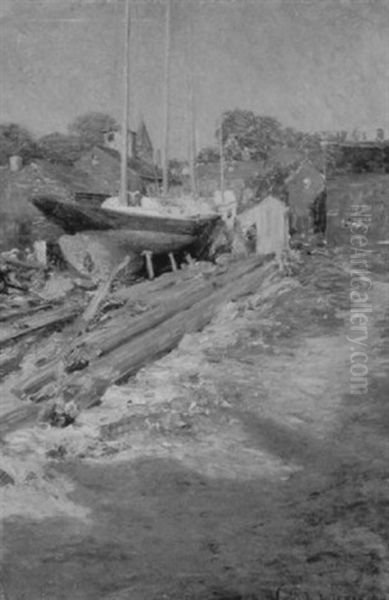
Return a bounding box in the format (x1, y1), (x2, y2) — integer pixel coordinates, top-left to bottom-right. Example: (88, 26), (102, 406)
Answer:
(0, 253), (389, 600)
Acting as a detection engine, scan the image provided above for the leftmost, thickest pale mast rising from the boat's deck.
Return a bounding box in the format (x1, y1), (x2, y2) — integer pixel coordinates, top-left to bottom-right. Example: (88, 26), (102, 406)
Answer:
(120, 0), (131, 206)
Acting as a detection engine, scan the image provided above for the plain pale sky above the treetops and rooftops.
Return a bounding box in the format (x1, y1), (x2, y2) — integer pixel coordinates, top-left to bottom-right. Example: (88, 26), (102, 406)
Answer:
(0, 0), (389, 157)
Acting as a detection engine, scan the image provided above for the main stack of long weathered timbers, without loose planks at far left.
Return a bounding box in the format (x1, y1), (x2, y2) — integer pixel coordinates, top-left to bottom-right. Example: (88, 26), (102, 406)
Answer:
(14, 256), (277, 418)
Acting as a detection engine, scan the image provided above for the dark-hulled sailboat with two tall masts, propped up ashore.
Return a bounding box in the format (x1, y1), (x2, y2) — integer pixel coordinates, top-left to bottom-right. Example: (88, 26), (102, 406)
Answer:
(31, 0), (220, 253)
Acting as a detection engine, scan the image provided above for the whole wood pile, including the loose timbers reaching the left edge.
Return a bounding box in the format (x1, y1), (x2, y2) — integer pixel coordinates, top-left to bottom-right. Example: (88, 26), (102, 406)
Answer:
(0, 256), (276, 433)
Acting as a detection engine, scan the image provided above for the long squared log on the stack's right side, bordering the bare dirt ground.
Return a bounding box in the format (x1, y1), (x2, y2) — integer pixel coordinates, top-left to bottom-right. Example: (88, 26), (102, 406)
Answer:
(66, 263), (276, 408)
